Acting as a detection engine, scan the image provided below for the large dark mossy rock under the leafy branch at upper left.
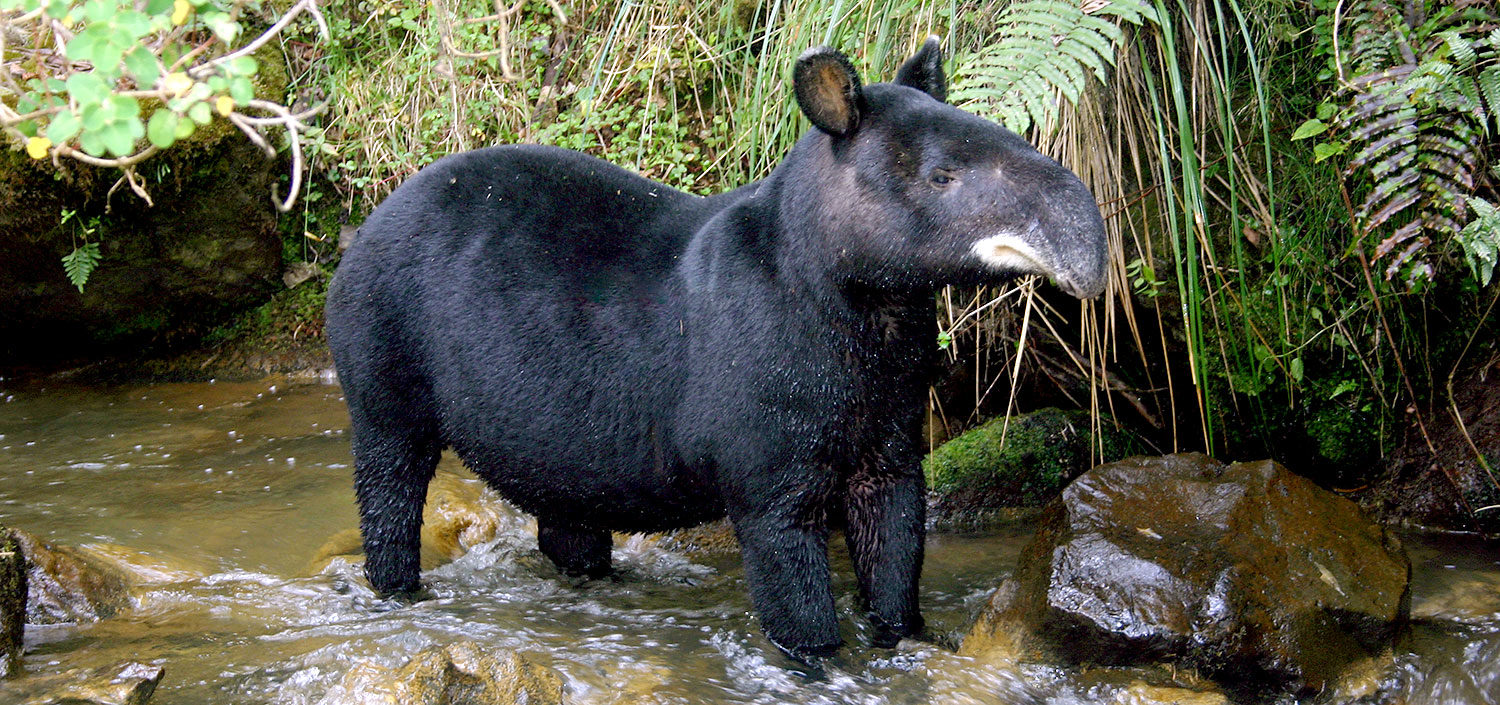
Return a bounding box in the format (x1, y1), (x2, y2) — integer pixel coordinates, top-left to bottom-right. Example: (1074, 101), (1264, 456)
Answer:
(0, 39), (287, 368)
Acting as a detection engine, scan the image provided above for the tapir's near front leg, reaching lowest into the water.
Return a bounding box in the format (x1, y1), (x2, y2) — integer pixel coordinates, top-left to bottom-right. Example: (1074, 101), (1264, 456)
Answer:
(726, 468), (843, 663)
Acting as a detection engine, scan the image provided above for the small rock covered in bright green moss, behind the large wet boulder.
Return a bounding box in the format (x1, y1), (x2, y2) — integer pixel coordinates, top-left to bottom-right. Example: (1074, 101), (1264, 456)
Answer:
(923, 408), (1136, 518)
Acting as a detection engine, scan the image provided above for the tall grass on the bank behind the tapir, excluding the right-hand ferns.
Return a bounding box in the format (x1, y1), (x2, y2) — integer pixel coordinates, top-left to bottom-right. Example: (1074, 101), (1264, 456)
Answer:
(290, 0), (1490, 501)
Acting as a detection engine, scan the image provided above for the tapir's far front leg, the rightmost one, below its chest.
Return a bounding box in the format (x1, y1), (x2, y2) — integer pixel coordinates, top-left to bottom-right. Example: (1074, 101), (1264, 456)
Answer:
(845, 435), (927, 648)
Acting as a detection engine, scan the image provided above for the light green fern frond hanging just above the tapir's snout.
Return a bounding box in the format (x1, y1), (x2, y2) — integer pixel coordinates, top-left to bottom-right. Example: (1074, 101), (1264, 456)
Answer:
(950, 0), (1155, 132)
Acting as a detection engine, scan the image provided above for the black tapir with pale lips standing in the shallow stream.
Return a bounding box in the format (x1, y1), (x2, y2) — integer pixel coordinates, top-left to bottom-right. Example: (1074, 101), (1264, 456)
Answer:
(327, 38), (1106, 660)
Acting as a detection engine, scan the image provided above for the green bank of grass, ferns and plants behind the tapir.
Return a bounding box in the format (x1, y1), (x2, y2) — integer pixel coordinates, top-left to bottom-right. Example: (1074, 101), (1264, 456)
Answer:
(2, 0), (1500, 507)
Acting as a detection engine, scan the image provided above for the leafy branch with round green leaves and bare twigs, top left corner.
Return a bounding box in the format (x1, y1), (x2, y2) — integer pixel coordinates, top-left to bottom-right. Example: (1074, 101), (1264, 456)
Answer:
(0, 0), (329, 212)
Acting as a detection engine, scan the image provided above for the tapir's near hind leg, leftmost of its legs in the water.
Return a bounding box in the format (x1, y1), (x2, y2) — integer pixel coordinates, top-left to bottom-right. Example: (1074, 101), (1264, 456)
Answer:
(350, 411), (443, 596)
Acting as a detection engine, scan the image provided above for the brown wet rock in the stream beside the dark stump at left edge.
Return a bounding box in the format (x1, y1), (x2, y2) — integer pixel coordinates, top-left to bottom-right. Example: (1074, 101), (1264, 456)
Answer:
(14, 530), (131, 624)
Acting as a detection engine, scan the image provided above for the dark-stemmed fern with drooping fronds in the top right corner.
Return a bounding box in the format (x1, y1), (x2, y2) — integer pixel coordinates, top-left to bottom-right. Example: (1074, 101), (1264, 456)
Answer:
(1343, 0), (1500, 287)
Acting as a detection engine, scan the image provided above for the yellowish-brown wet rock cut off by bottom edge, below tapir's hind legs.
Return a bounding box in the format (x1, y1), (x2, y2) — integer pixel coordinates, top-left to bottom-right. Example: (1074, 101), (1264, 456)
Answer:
(320, 641), (563, 705)
